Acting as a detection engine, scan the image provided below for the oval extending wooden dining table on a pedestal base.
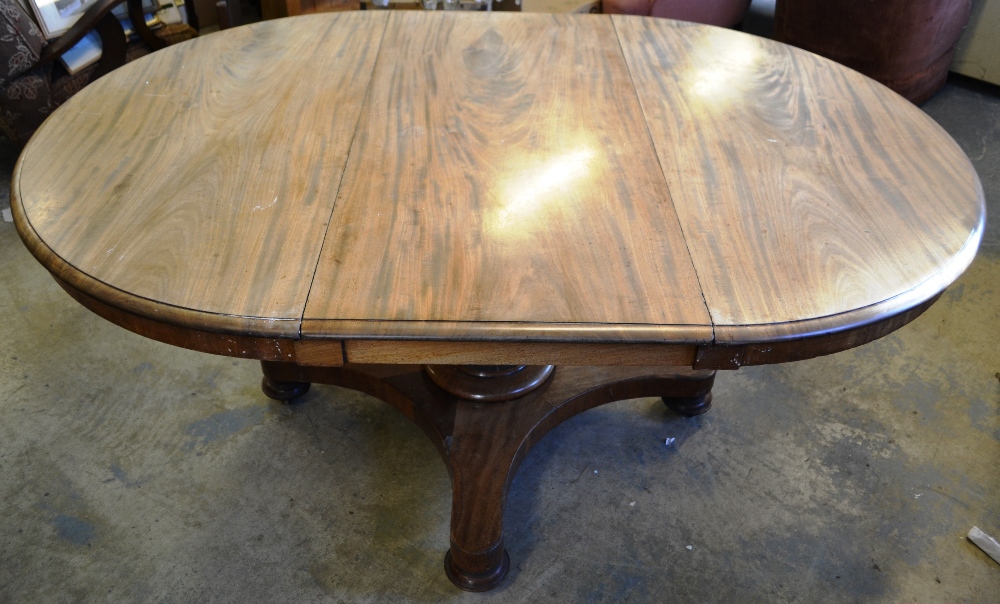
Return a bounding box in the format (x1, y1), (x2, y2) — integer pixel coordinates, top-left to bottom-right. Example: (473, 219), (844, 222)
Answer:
(11, 11), (985, 591)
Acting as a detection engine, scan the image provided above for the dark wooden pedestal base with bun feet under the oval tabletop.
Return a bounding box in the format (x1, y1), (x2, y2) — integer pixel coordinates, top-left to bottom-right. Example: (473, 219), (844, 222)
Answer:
(261, 361), (715, 591)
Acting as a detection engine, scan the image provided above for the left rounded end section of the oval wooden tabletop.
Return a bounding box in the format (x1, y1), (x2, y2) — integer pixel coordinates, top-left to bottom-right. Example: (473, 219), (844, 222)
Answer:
(13, 13), (386, 336)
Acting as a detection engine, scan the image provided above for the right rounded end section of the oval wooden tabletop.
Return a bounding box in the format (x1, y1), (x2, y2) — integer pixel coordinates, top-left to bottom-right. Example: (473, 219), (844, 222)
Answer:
(613, 16), (984, 343)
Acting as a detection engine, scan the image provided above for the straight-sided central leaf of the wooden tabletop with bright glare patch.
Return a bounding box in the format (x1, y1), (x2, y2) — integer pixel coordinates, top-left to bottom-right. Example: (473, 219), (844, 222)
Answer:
(303, 12), (711, 341)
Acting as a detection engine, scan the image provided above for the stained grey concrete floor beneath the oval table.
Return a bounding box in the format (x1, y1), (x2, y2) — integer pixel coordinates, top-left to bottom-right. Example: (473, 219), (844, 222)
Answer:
(0, 75), (1000, 603)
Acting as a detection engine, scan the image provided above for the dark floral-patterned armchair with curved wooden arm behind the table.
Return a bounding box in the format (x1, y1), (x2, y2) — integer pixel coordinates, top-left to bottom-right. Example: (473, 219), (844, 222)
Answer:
(0, 0), (198, 146)
